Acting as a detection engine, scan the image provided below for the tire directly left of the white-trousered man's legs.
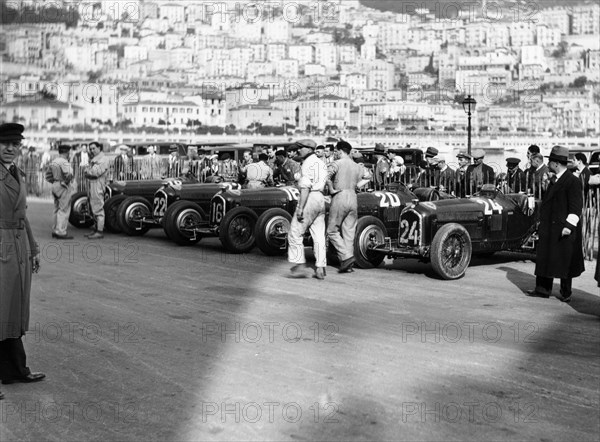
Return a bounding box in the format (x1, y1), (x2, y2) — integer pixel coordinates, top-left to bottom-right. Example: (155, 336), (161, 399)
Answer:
(254, 208), (292, 256)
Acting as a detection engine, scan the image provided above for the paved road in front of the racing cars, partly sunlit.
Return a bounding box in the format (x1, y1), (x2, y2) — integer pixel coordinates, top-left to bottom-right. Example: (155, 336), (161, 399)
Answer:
(0, 202), (600, 442)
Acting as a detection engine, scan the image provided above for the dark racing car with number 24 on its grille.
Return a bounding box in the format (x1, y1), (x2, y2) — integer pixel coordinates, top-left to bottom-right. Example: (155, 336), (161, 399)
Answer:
(368, 185), (537, 280)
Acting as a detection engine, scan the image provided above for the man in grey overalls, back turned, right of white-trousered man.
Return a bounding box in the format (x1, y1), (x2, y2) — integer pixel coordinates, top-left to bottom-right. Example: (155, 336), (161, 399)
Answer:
(327, 141), (368, 273)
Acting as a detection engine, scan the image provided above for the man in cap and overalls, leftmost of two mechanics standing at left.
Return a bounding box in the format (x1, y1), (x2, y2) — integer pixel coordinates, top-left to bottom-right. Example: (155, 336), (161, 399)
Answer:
(47, 145), (73, 239)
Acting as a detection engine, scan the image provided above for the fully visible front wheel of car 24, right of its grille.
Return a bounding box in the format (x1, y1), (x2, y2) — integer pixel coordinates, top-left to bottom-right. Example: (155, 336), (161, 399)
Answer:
(430, 223), (473, 280)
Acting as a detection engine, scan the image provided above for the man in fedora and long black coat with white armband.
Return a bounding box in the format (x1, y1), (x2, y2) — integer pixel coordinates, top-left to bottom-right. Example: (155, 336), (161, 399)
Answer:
(527, 146), (584, 302)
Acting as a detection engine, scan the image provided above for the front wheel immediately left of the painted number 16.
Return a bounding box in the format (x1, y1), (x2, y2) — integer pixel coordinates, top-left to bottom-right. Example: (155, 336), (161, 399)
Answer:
(163, 201), (207, 246)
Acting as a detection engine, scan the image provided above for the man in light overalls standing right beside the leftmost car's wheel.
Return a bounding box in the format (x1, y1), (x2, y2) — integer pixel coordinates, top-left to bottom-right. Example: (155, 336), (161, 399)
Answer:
(85, 141), (110, 239)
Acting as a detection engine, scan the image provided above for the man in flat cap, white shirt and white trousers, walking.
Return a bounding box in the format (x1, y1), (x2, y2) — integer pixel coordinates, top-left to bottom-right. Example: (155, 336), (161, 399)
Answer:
(288, 140), (327, 280)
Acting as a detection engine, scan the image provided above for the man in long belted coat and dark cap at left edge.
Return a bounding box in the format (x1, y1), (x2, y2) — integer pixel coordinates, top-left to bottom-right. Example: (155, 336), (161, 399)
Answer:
(0, 123), (45, 399)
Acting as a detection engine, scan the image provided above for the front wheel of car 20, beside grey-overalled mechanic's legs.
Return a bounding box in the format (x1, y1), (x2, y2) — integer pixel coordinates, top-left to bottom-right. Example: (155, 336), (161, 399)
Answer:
(354, 216), (387, 269)
